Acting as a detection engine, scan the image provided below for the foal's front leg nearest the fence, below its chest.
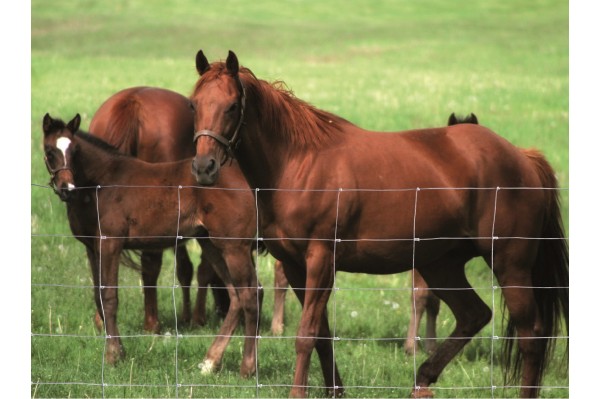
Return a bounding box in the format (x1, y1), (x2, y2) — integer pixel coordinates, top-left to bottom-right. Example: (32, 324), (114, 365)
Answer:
(96, 239), (125, 364)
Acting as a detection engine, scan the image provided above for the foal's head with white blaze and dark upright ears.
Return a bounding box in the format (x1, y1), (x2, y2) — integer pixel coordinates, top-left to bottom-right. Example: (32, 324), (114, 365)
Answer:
(42, 114), (81, 201)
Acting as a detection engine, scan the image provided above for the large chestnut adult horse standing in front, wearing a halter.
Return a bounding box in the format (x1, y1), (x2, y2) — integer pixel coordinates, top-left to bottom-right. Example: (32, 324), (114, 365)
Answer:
(190, 51), (569, 397)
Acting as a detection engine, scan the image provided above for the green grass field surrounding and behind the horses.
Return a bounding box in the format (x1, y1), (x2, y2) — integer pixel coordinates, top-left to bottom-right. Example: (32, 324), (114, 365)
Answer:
(31, 0), (569, 398)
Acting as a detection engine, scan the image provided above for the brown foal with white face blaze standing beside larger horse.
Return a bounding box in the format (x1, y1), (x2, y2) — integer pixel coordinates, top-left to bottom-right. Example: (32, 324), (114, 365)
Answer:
(42, 114), (262, 377)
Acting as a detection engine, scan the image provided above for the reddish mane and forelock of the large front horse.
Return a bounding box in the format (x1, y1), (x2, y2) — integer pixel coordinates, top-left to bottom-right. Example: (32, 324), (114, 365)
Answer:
(194, 62), (350, 151)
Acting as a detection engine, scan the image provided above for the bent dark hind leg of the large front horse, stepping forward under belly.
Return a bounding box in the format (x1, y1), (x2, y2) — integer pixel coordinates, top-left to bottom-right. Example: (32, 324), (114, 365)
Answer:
(412, 259), (492, 398)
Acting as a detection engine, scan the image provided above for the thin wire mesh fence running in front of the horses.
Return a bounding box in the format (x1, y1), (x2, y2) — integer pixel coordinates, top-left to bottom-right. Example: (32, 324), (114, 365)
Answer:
(31, 184), (569, 397)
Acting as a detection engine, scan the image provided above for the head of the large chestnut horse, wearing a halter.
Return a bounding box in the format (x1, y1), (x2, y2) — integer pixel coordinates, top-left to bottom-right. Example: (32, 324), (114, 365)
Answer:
(190, 50), (246, 185)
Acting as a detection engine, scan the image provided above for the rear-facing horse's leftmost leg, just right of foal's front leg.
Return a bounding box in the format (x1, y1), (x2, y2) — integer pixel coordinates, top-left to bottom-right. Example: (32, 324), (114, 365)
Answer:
(141, 251), (162, 334)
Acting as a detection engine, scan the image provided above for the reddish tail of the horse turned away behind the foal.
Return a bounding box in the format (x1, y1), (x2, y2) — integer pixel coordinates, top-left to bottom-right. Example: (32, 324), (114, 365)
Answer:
(105, 95), (141, 157)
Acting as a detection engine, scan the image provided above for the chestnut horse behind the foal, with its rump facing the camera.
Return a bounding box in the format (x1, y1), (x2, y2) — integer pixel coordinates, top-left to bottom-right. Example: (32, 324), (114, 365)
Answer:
(89, 86), (288, 335)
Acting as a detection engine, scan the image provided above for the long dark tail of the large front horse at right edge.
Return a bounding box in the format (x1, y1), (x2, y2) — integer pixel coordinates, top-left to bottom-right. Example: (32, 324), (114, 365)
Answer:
(503, 150), (569, 385)
